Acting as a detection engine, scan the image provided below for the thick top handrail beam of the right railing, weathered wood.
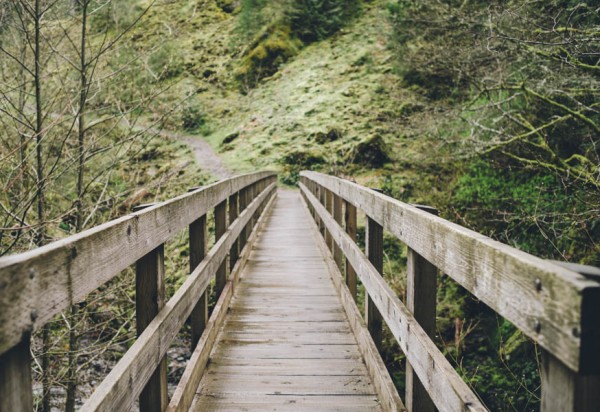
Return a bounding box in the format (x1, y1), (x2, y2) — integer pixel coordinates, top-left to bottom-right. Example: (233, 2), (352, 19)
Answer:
(301, 172), (600, 373)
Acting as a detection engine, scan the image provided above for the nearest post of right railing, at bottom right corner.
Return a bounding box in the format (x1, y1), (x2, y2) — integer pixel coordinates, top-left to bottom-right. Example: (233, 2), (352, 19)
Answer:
(536, 262), (600, 412)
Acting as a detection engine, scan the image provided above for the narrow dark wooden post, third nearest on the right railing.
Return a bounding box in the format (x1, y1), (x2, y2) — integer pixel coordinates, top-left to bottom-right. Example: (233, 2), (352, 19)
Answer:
(365, 216), (383, 350)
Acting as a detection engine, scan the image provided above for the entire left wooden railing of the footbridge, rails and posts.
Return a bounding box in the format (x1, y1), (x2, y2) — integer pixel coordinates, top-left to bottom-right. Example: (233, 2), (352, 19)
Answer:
(0, 172), (276, 412)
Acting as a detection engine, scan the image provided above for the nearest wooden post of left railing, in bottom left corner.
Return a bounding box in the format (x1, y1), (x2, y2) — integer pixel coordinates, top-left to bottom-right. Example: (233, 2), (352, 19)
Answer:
(0, 336), (33, 412)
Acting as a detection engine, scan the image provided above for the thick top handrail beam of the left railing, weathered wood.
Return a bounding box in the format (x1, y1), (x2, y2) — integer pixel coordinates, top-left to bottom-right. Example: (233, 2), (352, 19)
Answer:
(0, 172), (273, 353)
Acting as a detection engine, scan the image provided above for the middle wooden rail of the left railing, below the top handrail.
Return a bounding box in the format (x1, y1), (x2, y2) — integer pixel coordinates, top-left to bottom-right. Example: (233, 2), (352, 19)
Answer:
(82, 184), (276, 412)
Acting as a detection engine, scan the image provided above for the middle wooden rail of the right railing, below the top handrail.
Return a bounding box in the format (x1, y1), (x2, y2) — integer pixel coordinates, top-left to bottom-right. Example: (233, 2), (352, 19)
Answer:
(300, 184), (486, 411)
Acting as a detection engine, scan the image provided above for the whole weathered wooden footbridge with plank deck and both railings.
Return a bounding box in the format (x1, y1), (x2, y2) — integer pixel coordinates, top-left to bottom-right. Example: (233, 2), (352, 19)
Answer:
(0, 172), (600, 412)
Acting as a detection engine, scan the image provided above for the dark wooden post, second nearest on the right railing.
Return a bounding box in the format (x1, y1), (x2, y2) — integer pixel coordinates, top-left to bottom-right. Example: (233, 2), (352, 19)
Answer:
(405, 205), (438, 412)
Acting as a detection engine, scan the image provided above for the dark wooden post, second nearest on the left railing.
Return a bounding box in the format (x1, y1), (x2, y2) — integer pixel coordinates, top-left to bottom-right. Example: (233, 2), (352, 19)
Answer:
(135, 245), (169, 412)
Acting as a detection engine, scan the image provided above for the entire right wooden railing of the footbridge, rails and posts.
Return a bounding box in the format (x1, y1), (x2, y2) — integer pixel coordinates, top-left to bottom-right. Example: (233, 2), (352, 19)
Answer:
(299, 172), (600, 412)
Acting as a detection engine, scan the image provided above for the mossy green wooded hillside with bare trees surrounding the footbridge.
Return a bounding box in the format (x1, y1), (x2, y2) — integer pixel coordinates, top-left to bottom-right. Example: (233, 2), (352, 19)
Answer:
(0, 0), (600, 411)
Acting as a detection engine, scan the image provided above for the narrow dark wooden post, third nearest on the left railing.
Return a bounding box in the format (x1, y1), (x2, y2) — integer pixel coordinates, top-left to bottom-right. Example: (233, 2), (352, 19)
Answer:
(190, 215), (208, 352)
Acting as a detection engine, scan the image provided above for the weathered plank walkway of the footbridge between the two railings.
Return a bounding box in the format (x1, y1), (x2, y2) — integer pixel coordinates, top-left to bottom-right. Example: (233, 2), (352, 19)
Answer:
(192, 190), (380, 411)
